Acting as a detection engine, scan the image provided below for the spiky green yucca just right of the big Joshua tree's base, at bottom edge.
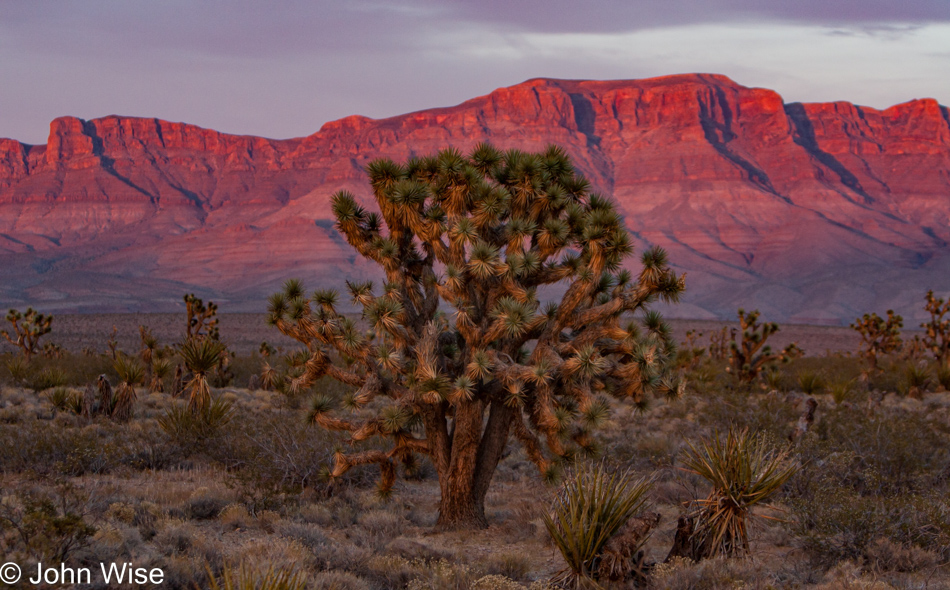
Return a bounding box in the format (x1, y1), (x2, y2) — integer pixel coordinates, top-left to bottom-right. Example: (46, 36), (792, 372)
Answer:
(544, 464), (652, 588)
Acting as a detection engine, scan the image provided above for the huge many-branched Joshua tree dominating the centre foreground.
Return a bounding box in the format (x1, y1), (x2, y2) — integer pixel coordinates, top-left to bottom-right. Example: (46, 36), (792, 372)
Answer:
(269, 145), (683, 527)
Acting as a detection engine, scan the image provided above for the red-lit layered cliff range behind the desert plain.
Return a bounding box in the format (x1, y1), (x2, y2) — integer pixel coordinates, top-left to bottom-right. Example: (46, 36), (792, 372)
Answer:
(0, 75), (950, 325)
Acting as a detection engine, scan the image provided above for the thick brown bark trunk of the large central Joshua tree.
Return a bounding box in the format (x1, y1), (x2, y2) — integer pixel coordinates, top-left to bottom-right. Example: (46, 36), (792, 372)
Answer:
(430, 401), (512, 529)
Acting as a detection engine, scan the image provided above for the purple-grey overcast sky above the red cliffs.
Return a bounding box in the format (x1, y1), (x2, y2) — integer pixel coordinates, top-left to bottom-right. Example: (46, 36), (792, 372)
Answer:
(0, 0), (950, 143)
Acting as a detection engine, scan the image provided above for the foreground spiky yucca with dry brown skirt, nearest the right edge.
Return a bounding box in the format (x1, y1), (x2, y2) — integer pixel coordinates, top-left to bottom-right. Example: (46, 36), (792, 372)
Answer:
(683, 429), (798, 560)
